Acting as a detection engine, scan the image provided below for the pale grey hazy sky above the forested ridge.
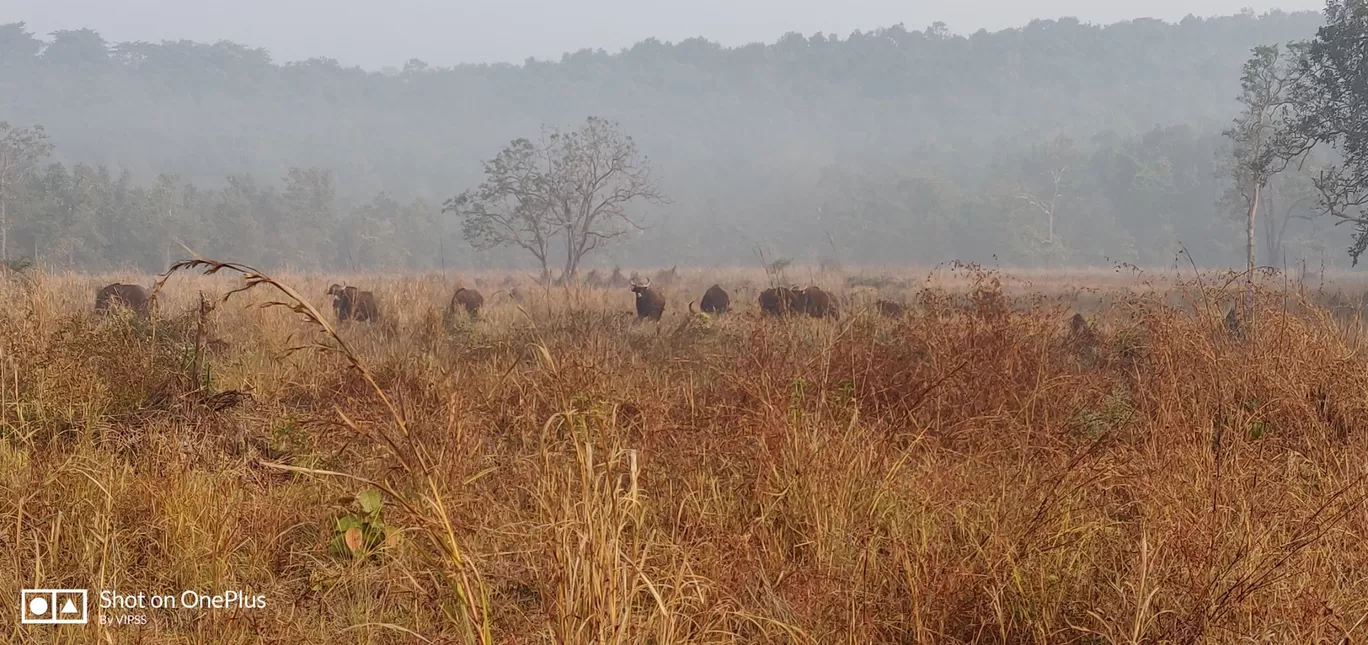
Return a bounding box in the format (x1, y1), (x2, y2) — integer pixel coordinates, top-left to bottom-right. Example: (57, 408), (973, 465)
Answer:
(0, 0), (1324, 68)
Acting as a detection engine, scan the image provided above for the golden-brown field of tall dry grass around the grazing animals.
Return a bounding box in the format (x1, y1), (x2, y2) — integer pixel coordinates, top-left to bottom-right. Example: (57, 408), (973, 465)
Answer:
(0, 260), (1368, 645)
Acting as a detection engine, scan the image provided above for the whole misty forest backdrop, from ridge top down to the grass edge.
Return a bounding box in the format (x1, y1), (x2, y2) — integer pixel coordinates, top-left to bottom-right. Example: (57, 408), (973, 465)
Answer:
(0, 12), (1347, 270)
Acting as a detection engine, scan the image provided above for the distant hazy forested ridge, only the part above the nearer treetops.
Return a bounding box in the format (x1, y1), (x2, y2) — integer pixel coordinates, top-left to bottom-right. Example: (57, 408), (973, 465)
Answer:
(0, 12), (1320, 197)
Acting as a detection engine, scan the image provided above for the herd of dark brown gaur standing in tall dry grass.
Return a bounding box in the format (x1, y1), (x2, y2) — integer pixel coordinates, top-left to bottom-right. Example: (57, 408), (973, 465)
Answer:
(94, 278), (904, 322)
